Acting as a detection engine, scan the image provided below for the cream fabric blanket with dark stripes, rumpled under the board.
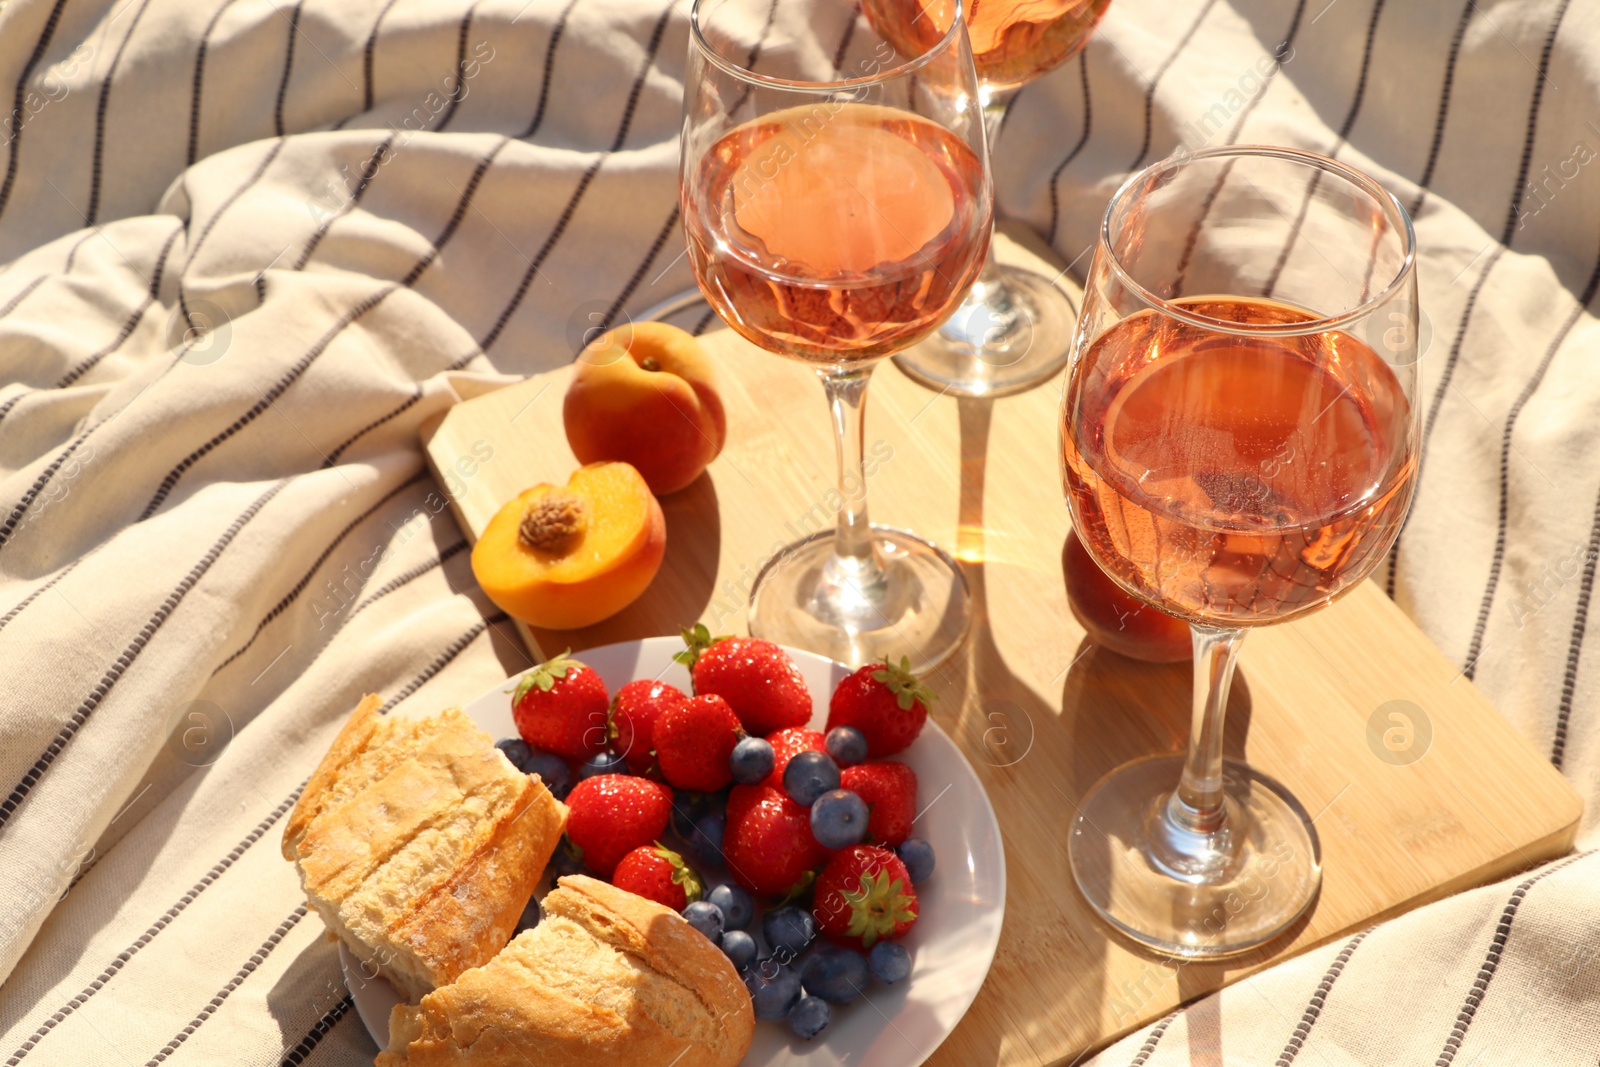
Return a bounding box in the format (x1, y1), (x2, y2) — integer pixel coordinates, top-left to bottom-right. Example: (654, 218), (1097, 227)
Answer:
(0, 0), (1600, 1067)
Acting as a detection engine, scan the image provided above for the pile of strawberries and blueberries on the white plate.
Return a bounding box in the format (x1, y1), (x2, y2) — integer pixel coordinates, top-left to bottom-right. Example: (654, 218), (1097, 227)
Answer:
(499, 625), (934, 1038)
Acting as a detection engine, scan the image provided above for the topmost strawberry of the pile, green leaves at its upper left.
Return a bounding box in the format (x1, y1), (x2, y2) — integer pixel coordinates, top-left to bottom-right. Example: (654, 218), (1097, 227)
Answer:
(674, 622), (811, 737)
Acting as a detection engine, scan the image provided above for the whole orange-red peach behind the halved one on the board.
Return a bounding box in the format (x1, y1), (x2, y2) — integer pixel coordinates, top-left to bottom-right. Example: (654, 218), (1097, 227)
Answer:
(562, 322), (728, 496)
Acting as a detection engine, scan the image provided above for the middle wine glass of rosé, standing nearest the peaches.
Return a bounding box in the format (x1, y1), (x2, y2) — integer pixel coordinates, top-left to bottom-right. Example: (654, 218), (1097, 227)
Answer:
(680, 0), (994, 670)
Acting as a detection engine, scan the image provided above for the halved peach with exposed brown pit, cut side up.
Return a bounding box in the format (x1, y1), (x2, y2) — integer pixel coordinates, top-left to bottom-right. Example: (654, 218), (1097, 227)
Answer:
(472, 462), (667, 630)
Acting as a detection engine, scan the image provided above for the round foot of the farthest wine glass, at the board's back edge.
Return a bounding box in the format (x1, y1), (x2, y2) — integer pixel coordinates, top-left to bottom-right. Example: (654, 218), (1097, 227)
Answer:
(894, 264), (1078, 397)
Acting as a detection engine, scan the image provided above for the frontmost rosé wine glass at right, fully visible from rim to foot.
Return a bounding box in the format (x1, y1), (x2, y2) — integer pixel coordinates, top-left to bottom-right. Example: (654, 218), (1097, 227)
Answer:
(1062, 146), (1419, 957)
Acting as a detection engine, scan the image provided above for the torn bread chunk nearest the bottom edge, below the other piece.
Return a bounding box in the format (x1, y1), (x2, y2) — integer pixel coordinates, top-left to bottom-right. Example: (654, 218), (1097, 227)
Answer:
(376, 875), (755, 1067)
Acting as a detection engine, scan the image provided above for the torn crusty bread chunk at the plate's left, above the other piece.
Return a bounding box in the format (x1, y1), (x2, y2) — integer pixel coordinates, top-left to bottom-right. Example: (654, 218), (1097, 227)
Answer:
(283, 696), (566, 1001)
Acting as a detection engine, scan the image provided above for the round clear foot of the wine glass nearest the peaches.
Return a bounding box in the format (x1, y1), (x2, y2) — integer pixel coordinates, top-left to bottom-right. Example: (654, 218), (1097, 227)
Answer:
(750, 526), (973, 673)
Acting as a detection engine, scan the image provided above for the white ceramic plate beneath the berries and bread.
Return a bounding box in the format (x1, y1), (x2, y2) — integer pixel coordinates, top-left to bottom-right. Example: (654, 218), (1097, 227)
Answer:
(341, 637), (1005, 1067)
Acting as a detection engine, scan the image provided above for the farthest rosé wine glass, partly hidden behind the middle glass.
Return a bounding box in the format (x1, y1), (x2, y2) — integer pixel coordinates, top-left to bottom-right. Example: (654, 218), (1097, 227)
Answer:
(862, 0), (1110, 397)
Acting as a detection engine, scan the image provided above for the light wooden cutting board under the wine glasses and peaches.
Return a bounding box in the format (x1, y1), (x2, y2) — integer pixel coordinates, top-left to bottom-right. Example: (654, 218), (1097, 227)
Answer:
(424, 231), (1582, 1067)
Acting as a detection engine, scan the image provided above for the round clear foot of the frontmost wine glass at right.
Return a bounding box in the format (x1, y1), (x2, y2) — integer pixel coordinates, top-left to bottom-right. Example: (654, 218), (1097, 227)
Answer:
(1069, 755), (1322, 958)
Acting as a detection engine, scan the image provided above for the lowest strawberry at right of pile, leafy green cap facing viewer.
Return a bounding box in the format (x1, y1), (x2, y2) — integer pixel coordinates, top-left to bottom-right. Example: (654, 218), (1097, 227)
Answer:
(811, 845), (917, 949)
